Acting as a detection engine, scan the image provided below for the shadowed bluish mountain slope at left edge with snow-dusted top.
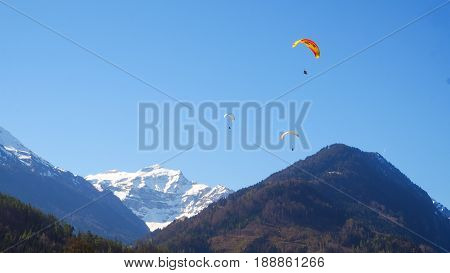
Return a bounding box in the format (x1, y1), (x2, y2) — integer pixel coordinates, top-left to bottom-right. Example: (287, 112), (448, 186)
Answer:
(0, 124), (148, 242)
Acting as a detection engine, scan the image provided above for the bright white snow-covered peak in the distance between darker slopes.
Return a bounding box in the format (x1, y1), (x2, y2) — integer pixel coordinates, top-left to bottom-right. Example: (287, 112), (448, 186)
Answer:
(85, 165), (232, 231)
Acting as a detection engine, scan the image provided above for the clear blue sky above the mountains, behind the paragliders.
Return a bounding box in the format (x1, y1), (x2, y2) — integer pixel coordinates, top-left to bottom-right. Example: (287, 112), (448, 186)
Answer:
(0, 0), (450, 206)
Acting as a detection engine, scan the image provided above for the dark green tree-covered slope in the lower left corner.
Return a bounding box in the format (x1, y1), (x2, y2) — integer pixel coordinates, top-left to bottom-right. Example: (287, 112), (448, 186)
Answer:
(0, 193), (164, 253)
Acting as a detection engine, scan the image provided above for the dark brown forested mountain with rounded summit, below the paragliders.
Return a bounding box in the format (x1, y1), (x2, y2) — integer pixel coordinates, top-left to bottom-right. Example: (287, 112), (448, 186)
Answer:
(154, 144), (450, 252)
